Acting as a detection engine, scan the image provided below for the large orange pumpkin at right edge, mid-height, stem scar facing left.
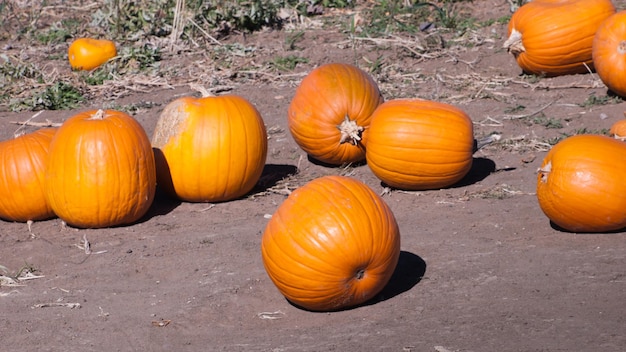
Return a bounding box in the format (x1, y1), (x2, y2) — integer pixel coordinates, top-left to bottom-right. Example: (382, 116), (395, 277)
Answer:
(537, 135), (626, 232)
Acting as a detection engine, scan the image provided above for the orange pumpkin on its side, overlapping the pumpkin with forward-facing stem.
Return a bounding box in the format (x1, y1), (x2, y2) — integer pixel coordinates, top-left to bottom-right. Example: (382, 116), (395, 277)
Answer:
(366, 99), (474, 190)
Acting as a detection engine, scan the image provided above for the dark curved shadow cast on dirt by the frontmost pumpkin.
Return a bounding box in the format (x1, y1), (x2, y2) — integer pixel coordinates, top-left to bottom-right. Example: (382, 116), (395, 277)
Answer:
(287, 251), (426, 313)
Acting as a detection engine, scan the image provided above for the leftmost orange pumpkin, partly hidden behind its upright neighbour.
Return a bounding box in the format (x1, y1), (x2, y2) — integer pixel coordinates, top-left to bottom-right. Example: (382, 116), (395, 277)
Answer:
(0, 128), (57, 222)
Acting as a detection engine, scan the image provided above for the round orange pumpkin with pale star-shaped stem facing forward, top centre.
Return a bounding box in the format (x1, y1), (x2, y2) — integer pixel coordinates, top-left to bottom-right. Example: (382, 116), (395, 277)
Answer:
(287, 63), (383, 165)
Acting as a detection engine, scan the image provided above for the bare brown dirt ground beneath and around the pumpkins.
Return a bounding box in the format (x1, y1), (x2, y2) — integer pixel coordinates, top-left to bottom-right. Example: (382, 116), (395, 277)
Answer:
(0, 0), (626, 352)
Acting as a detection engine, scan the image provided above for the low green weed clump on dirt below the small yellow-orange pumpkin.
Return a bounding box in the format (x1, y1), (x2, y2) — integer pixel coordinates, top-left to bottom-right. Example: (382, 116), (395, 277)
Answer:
(10, 81), (85, 111)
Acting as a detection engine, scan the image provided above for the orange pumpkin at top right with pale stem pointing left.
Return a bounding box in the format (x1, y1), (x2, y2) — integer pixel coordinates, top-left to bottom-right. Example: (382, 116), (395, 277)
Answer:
(503, 0), (615, 76)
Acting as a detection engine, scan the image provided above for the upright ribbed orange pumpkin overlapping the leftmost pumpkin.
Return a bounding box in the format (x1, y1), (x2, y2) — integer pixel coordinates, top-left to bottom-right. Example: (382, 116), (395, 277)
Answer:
(45, 110), (156, 228)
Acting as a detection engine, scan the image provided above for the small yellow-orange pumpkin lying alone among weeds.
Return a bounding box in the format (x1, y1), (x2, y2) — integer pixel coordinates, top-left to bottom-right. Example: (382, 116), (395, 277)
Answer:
(67, 38), (117, 70)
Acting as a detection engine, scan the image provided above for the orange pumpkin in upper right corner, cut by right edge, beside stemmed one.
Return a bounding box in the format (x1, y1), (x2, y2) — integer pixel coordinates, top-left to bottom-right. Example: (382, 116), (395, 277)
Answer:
(593, 10), (626, 97)
